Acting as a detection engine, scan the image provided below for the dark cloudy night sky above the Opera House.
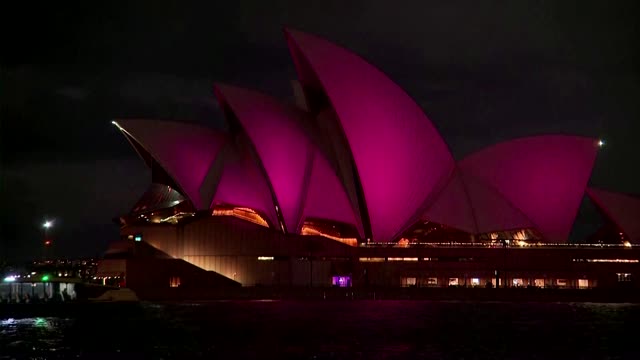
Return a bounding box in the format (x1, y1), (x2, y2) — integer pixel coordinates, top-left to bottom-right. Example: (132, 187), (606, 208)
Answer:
(0, 0), (640, 261)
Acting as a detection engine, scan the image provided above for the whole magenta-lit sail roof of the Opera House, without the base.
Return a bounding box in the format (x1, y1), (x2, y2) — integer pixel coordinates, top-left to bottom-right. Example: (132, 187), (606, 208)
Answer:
(114, 30), (640, 243)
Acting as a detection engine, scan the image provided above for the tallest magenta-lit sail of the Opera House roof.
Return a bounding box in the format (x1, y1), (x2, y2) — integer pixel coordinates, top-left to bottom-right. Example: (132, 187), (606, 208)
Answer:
(285, 30), (454, 242)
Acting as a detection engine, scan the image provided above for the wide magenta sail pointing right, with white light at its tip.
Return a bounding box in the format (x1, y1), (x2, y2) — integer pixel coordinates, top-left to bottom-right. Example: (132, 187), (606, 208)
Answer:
(459, 135), (598, 242)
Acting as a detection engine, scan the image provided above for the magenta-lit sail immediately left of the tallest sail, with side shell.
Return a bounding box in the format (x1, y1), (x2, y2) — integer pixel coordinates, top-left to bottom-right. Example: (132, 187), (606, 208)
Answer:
(216, 85), (361, 236)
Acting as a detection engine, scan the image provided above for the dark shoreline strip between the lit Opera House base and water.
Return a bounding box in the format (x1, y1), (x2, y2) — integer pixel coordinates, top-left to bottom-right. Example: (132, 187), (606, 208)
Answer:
(0, 287), (640, 319)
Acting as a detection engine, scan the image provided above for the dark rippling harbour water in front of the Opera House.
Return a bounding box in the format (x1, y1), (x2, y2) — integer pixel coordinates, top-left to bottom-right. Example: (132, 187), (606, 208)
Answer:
(0, 301), (640, 359)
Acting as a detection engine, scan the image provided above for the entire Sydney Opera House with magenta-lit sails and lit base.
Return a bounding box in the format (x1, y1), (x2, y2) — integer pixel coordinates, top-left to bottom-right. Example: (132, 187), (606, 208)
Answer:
(99, 30), (640, 288)
